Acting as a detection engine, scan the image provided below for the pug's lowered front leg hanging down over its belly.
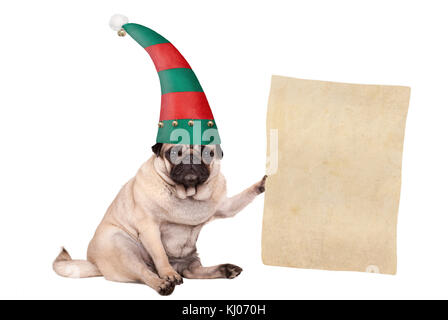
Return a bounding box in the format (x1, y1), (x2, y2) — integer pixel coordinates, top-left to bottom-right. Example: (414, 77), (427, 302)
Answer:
(140, 219), (182, 284)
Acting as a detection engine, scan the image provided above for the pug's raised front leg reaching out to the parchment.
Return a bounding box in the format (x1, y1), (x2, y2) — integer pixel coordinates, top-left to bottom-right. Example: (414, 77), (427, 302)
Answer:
(215, 176), (267, 218)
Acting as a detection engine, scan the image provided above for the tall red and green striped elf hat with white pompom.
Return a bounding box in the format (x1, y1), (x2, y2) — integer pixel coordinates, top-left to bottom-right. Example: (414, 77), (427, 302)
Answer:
(109, 15), (221, 145)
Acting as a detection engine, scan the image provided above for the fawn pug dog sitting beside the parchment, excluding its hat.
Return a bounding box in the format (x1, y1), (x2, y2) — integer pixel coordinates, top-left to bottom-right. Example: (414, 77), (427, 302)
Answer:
(53, 143), (266, 295)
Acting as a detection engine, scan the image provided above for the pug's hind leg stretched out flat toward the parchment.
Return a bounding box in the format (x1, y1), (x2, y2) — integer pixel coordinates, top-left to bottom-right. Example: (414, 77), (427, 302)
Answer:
(182, 261), (243, 279)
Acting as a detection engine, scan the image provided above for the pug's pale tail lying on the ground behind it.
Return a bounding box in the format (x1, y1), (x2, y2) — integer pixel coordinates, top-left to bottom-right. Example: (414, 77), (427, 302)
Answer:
(53, 247), (102, 278)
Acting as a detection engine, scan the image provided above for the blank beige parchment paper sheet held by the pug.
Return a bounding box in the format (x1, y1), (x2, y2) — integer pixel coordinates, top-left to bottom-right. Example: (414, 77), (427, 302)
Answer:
(262, 76), (410, 274)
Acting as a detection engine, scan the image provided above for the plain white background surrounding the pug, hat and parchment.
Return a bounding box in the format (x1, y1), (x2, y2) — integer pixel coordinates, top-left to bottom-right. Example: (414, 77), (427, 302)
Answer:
(0, 0), (448, 299)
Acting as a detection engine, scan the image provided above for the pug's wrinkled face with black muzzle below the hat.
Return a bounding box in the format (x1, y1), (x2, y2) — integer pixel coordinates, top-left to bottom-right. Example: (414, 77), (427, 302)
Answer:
(152, 143), (223, 189)
